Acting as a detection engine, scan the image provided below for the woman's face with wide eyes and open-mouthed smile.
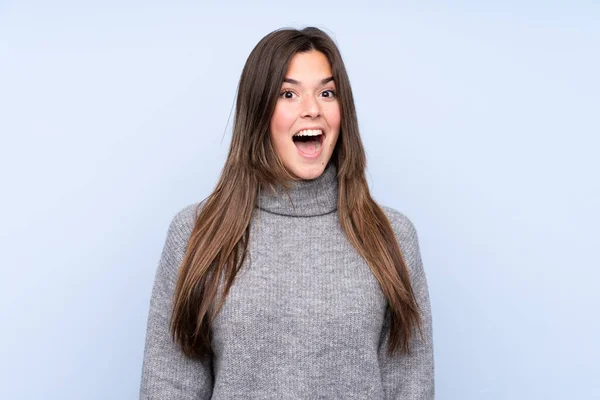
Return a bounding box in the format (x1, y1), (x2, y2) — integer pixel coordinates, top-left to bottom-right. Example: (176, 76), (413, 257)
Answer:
(270, 50), (341, 179)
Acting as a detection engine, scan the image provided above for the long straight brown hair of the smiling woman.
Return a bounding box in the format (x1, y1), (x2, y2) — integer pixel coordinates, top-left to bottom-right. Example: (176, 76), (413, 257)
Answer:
(171, 27), (421, 358)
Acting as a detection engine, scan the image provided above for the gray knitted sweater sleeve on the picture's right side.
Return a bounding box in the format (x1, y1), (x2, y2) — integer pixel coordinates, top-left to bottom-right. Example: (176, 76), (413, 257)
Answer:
(379, 208), (435, 400)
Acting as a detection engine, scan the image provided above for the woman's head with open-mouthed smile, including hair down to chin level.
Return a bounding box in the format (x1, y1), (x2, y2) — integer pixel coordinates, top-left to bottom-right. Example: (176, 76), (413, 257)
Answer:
(227, 27), (365, 183)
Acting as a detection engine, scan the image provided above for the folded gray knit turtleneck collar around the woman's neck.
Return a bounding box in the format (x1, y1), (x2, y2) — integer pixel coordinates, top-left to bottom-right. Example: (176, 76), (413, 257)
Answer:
(258, 162), (338, 217)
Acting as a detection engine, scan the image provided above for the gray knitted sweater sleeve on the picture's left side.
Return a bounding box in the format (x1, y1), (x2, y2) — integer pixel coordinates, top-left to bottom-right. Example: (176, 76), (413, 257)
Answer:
(140, 206), (213, 400)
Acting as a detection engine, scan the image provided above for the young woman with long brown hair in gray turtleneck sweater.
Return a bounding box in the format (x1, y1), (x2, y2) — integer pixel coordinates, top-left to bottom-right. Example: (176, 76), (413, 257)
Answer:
(140, 28), (434, 400)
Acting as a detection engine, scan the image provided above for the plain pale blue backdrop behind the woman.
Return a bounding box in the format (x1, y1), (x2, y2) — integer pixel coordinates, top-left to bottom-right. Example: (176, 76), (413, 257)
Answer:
(0, 0), (600, 400)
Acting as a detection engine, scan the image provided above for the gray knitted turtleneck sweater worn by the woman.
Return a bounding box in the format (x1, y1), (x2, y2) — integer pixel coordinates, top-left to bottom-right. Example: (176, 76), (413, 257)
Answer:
(140, 164), (434, 400)
